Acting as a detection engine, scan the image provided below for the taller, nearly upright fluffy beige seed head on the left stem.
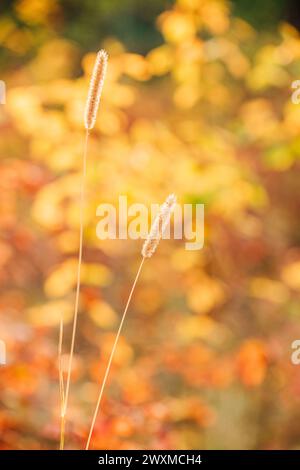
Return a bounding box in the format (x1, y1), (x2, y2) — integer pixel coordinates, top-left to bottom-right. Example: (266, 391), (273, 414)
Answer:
(84, 49), (108, 130)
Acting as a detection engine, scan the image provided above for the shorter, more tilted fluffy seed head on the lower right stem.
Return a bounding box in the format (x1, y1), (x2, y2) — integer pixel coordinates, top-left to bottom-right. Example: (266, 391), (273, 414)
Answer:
(142, 194), (176, 258)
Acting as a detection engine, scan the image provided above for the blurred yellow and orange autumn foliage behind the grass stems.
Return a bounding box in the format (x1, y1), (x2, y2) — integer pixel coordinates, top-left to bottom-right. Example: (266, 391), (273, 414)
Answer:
(0, 0), (300, 449)
